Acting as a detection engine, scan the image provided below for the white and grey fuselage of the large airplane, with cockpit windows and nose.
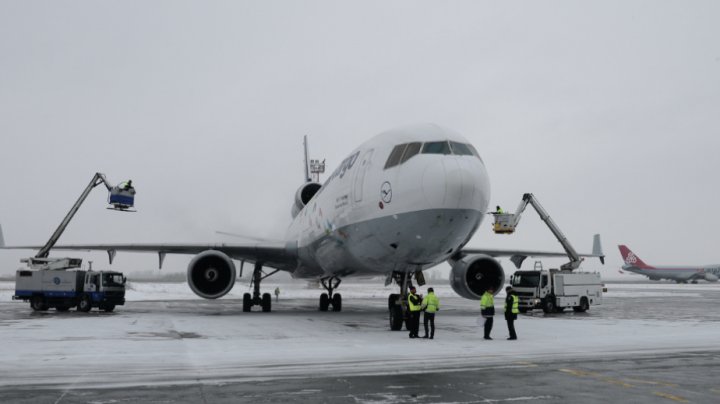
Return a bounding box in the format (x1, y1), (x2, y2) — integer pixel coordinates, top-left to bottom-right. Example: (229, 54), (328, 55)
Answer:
(286, 125), (490, 278)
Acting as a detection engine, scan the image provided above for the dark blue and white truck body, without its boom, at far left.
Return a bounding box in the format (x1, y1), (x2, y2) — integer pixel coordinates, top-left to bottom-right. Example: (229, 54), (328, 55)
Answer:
(13, 269), (126, 312)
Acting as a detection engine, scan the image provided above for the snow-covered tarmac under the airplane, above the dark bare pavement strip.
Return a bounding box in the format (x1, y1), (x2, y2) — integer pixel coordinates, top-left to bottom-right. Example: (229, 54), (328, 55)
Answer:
(0, 282), (720, 399)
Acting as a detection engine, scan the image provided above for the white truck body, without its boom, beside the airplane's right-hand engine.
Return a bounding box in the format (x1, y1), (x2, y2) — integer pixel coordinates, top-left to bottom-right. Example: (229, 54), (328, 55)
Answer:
(510, 269), (603, 313)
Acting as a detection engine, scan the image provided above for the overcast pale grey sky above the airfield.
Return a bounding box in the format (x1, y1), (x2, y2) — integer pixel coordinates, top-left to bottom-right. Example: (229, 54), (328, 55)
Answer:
(0, 0), (720, 276)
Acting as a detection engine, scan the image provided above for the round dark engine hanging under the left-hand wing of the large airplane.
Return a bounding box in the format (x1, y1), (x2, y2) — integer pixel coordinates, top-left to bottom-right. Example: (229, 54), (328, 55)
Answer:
(188, 250), (235, 299)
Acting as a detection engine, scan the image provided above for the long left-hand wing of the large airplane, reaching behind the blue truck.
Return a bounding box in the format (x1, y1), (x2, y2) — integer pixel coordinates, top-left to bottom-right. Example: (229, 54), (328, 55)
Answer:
(0, 242), (297, 270)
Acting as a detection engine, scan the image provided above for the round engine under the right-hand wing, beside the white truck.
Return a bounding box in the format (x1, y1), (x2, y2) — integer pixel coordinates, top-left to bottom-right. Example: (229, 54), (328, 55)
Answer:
(448, 254), (505, 300)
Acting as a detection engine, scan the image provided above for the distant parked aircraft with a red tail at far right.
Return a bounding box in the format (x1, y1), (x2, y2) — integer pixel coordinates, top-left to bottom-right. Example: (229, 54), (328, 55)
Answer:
(618, 245), (720, 283)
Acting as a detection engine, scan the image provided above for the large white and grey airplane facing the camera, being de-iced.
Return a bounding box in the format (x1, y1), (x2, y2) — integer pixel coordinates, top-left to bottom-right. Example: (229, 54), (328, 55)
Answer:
(4, 124), (604, 330)
